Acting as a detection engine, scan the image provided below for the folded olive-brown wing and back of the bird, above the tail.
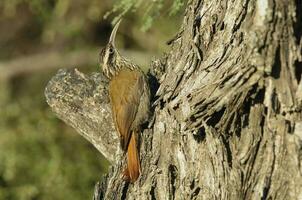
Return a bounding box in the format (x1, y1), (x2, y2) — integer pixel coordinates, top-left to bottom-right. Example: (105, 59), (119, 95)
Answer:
(109, 70), (143, 151)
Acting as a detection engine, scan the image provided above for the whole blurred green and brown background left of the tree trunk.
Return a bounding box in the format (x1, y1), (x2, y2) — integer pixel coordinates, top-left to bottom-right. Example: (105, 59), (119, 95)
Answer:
(0, 0), (184, 200)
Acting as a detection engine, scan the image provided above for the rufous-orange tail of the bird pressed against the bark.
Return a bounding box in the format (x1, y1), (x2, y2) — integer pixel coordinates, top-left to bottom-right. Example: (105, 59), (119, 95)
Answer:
(125, 132), (140, 183)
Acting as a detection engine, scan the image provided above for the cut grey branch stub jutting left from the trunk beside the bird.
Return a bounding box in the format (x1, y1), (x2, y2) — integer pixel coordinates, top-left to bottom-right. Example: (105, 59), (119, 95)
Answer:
(45, 69), (119, 163)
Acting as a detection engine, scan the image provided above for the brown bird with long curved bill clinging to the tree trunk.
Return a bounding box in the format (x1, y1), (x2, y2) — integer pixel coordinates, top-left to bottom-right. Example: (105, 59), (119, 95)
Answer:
(100, 19), (150, 183)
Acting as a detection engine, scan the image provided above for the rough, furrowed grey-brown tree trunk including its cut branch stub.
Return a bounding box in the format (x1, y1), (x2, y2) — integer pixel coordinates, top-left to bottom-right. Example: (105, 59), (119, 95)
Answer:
(45, 0), (302, 200)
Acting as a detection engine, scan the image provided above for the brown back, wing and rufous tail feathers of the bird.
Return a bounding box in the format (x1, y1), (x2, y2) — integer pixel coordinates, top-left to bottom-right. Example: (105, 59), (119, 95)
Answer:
(109, 69), (144, 182)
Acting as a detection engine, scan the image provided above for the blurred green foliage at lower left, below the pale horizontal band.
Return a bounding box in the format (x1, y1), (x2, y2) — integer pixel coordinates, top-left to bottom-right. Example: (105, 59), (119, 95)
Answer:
(0, 75), (108, 200)
